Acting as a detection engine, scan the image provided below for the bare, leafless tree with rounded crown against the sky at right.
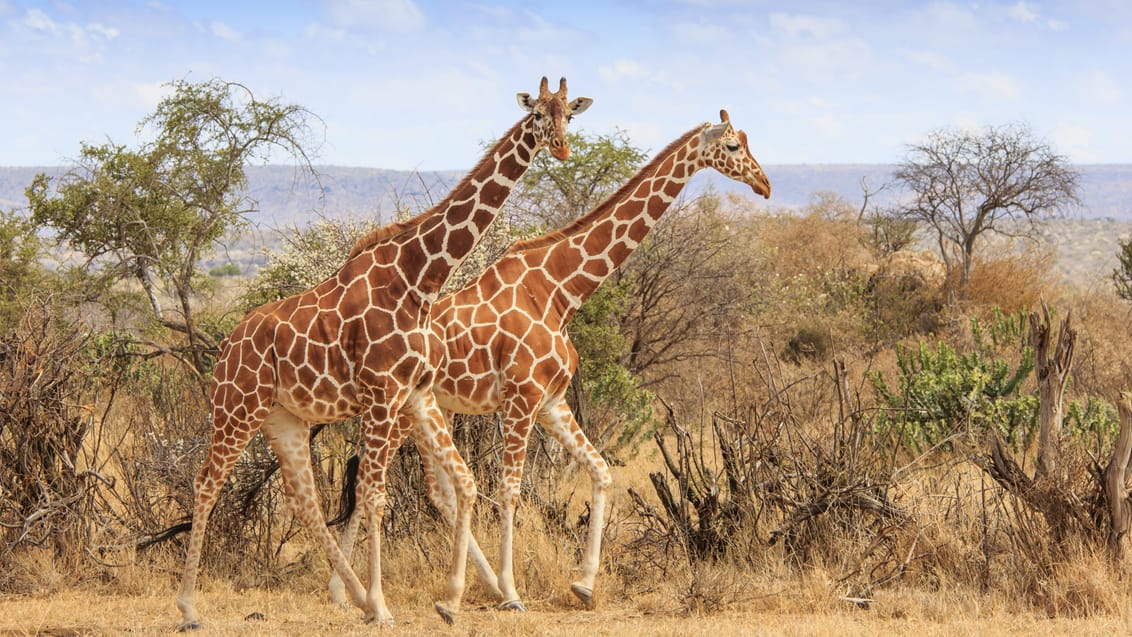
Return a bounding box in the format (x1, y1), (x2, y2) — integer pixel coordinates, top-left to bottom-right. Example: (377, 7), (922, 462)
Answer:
(894, 124), (1078, 294)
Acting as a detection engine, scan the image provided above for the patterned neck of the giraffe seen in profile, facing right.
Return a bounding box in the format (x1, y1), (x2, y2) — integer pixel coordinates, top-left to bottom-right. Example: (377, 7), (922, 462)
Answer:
(509, 128), (703, 322)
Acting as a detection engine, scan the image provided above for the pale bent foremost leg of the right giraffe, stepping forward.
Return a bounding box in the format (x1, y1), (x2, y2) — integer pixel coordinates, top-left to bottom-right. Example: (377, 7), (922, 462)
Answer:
(539, 397), (614, 609)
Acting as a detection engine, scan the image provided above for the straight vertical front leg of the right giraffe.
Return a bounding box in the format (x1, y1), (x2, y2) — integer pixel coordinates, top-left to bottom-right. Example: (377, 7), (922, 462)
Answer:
(499, 396), (538, 611)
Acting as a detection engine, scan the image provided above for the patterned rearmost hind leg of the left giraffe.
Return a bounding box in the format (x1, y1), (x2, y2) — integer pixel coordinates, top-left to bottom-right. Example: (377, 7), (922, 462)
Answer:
(177, 413), (256, 631)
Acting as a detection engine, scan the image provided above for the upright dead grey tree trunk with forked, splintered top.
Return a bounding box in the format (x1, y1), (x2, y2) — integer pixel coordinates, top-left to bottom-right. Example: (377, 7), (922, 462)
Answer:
(1030, 301), (1077, 481)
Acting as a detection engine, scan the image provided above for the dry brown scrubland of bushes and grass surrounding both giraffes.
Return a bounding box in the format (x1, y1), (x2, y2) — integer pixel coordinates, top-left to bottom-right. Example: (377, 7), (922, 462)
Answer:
(0, 79), (1132, 635)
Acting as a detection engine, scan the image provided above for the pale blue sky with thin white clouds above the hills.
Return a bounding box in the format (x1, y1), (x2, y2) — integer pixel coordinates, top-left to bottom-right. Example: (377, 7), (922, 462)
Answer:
(0, 0), (1132, 170)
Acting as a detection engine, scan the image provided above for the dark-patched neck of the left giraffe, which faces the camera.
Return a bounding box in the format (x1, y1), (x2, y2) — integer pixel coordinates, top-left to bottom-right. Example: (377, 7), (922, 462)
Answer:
(351, 115), (539, 298)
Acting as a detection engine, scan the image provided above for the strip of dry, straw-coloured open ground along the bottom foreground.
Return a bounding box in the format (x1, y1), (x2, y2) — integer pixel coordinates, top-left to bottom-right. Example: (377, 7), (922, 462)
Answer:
(0, 588), (1132, 637)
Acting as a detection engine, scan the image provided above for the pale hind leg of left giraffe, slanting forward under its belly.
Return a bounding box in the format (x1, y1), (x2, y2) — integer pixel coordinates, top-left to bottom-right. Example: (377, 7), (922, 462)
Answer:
(263, 407), (376, 614)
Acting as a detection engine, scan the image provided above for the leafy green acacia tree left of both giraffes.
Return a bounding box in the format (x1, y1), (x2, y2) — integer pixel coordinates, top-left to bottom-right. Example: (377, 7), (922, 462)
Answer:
(26, 79), (314, 375)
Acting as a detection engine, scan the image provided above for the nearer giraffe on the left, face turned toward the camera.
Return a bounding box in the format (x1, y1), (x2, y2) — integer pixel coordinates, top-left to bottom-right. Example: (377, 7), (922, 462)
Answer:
(177, 77), (592, 629)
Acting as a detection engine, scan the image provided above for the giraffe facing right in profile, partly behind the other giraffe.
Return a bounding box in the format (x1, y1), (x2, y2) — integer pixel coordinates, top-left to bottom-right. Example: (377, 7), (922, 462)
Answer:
(343, 110), (771, 610)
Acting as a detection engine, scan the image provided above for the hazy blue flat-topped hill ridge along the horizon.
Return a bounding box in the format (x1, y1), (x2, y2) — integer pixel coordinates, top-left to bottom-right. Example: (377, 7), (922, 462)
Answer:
(0, 164), (1132, 227)
